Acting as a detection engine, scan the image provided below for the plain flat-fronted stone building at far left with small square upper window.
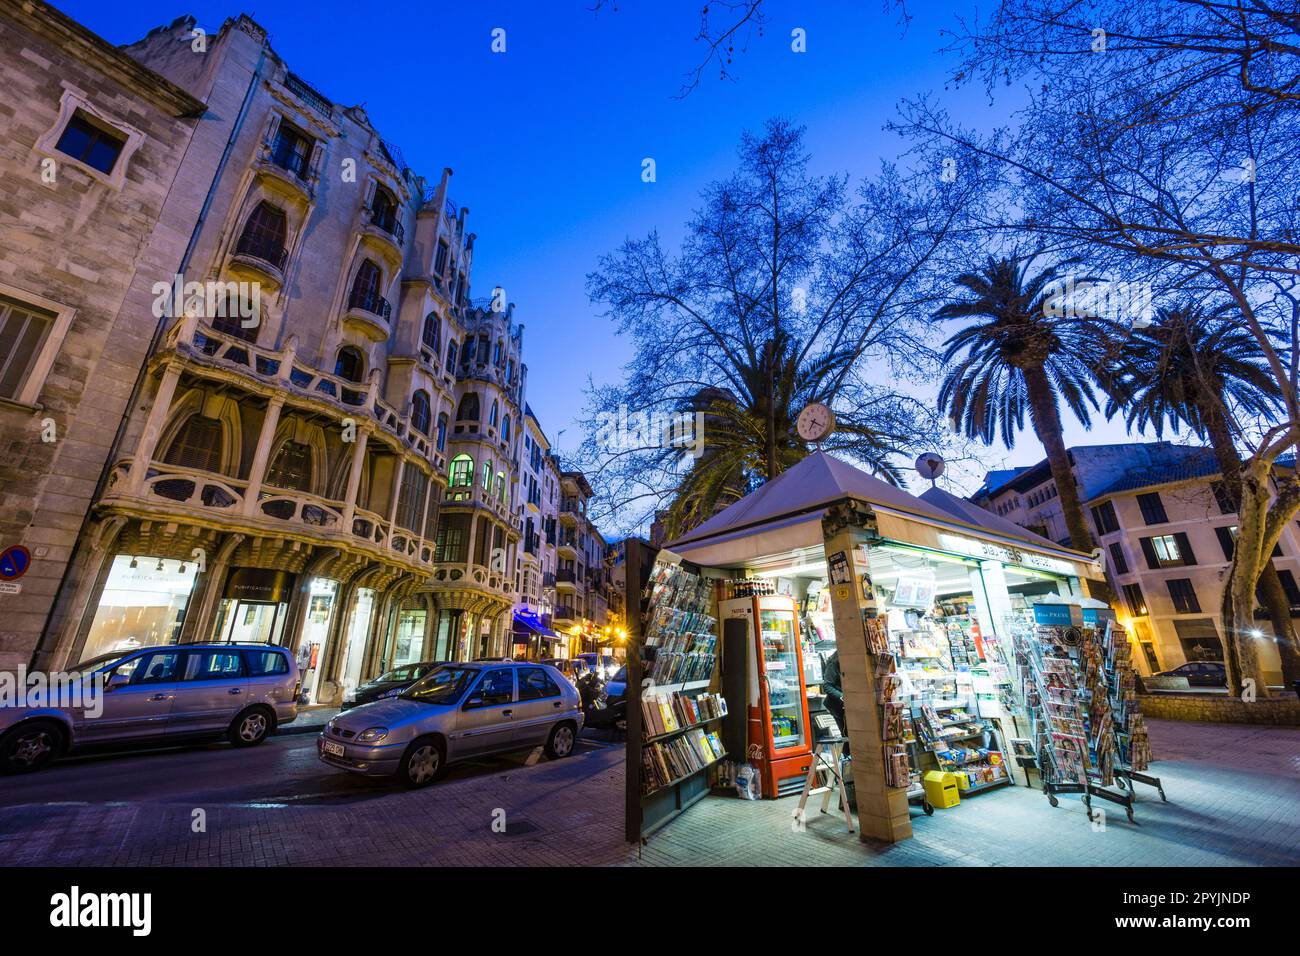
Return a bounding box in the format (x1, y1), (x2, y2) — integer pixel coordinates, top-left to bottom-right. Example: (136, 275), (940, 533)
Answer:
(0, 0), (205, 670)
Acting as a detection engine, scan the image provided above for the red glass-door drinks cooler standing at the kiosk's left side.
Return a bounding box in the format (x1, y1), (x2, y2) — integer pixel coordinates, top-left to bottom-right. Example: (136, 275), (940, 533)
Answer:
(719, 594), (813, 799)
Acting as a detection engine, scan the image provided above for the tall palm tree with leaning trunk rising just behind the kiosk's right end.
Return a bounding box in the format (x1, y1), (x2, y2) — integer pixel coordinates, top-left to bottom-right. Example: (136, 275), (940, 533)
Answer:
(935, 256), (1118, 551)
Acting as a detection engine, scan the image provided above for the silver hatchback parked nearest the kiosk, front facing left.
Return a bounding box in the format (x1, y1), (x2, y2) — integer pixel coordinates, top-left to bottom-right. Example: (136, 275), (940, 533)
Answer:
(316, 661), (582, 787)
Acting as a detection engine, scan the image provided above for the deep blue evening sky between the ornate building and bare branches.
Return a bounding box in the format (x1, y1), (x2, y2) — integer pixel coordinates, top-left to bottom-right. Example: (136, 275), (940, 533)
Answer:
(56, 0), (1154, 502)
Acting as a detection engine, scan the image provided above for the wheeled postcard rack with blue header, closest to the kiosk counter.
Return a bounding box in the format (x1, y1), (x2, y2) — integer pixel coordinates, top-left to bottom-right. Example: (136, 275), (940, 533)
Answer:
(1015, 626), (1136, 822)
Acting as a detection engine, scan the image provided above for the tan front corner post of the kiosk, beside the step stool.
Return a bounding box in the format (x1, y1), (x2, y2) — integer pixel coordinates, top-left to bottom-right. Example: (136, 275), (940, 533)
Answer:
(822, 498), (911, 843)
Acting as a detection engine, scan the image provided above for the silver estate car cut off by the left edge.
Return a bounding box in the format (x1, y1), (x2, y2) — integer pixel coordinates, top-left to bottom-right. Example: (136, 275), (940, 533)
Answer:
(0, 644), (298, 773)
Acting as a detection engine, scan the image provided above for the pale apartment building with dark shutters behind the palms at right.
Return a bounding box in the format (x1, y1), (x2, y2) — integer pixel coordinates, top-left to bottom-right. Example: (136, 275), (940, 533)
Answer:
(971, 442), (1300, 683)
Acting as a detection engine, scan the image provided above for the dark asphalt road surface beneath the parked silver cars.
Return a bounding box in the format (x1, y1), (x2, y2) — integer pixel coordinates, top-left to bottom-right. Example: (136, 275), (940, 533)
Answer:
(0, 734), (610, 806)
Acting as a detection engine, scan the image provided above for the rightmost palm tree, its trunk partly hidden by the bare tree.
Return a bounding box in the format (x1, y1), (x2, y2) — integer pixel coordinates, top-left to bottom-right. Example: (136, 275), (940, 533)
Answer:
(1106, 304), (1300, 683)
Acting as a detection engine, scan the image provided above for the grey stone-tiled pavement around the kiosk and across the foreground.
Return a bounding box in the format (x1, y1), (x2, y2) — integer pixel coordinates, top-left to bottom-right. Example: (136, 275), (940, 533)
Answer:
(0, 721), (1300, 866)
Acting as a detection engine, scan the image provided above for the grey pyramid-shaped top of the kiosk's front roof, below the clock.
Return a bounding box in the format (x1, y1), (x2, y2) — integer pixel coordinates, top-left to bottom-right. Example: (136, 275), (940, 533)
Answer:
(668, 451), (972, 549)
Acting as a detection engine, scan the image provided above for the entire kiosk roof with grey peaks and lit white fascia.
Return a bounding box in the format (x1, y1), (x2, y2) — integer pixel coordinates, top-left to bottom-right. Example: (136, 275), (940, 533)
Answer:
(667, 451), (1100, 578)
